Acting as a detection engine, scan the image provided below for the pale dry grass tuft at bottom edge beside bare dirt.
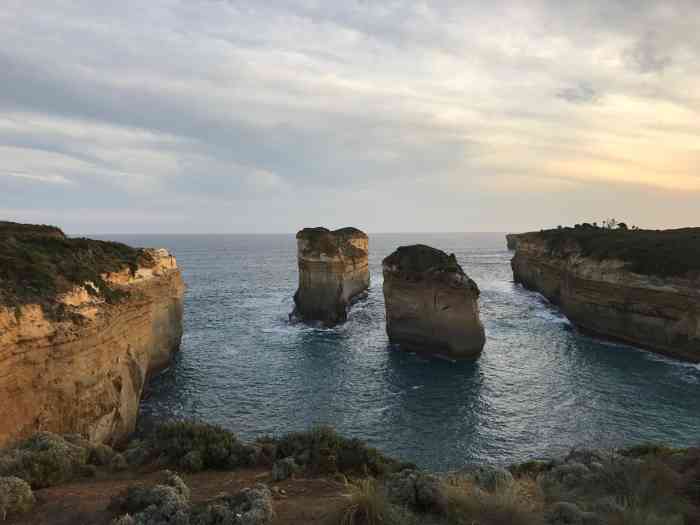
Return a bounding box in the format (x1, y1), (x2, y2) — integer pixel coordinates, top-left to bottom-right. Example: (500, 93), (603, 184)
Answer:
(326, 479), (417, 525)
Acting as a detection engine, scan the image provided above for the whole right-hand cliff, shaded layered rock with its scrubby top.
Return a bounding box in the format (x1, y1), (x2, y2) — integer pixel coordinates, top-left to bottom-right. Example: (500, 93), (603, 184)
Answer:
(511, 225), (700, 362)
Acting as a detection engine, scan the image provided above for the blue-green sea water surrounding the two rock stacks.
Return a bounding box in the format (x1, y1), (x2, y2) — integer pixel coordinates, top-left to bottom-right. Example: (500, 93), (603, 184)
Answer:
(104, 234), (700, 470)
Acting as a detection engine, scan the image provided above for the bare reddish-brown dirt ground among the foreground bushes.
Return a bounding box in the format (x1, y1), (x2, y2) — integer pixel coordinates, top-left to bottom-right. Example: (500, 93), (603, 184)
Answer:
(5, 469), (349, 525)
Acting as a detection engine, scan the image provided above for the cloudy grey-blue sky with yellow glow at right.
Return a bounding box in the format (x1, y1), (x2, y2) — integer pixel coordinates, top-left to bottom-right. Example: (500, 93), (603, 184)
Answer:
(0, 0), (700, 233)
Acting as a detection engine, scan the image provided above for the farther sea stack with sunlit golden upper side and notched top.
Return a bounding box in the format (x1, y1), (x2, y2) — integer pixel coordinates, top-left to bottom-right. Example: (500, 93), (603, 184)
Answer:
(292, 227), (369, 326)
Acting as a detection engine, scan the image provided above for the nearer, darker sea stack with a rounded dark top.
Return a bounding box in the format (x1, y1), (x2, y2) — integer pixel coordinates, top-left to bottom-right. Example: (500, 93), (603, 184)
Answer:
(382, 244), (485, 358)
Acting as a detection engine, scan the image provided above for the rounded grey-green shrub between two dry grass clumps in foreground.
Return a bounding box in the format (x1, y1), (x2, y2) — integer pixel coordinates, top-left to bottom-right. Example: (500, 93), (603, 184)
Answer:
(385, 469), (447, 514)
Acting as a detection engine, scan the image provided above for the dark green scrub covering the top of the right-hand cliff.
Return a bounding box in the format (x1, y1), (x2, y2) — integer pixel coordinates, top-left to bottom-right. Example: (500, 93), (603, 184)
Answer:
(520, 223), (700, 277)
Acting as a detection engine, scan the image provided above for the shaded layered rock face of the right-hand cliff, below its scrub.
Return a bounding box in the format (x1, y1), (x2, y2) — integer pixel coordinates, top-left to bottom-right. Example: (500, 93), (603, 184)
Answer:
(511, 233), (700, 362)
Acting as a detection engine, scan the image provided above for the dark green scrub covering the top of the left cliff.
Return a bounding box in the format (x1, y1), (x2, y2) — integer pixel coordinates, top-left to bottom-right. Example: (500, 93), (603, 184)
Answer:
(0, 222), (152, 306)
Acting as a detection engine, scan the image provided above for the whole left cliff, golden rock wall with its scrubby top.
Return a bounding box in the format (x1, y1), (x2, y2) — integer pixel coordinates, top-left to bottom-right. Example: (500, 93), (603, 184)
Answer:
(0, 223), (184, 446)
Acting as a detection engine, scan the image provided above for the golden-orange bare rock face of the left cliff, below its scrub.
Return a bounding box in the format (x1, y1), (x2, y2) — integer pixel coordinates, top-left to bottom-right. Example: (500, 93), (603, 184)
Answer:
(0, 250), (184, 447)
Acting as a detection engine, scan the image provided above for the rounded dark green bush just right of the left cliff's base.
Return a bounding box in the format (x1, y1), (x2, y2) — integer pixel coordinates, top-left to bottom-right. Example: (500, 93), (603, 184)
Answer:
(153, 421), (256, 470)
